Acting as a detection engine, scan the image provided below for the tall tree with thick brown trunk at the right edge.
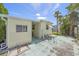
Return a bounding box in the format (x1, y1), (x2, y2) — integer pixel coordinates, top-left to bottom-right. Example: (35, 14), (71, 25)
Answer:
(66, 3), (79, 36)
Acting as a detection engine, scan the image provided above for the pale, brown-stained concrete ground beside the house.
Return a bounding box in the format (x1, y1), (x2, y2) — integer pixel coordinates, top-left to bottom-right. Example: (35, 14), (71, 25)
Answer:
(20, 36), (79, 56)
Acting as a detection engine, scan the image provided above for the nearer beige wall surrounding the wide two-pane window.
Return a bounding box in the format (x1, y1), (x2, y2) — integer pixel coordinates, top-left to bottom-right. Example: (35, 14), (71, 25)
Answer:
(6, 17), (32, 48)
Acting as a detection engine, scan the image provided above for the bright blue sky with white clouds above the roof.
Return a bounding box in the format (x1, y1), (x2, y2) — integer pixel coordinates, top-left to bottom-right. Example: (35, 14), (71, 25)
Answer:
(4, 3), (69, 25)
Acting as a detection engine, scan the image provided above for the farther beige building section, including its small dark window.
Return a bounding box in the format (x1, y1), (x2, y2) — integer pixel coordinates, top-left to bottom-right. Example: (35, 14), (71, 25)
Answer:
(33, 20), (52, 38)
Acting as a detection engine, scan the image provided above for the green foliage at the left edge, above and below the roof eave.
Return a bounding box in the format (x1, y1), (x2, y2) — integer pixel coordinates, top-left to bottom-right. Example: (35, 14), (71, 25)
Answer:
(0, 3), (8, 42)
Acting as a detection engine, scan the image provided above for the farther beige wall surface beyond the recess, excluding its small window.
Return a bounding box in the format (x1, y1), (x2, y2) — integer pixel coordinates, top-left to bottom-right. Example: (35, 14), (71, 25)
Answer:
(34, 21), (52, 38)
